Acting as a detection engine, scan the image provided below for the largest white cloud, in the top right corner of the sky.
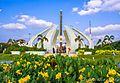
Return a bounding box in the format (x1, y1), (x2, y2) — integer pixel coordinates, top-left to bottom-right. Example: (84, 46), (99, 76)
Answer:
(78, 0), (120, 15)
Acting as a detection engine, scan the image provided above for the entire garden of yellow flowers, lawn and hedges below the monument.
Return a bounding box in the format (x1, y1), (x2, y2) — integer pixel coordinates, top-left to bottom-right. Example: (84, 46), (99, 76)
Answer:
(0, 42), (120, 83)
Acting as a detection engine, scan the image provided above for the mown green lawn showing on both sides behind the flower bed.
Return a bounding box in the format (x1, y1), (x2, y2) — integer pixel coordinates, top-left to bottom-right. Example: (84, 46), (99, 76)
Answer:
(0, 54), (120, 62)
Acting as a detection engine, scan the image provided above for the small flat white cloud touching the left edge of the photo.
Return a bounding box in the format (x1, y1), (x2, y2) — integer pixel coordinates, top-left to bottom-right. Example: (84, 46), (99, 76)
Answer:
(0, 23), (26, 29)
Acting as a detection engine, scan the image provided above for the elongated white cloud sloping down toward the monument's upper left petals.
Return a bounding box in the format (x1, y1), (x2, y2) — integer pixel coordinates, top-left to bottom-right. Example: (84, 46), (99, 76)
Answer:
(17, 15), (53, 27)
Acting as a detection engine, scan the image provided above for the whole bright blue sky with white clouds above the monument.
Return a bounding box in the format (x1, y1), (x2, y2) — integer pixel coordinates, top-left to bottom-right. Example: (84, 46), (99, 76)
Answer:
(0, 0), (120, 42)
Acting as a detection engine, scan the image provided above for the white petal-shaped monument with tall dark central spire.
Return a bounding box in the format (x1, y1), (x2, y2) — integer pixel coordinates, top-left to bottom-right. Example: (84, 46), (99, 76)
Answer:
(27, 10), (94, 53)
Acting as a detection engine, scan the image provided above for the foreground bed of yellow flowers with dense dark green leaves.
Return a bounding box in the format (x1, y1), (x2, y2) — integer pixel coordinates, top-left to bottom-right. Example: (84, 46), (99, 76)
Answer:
(0, 54), (120, 83)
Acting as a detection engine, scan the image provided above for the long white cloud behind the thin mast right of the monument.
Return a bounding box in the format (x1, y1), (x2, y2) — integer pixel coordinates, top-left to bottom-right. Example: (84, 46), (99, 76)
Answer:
(85, 24), (120, 34)
